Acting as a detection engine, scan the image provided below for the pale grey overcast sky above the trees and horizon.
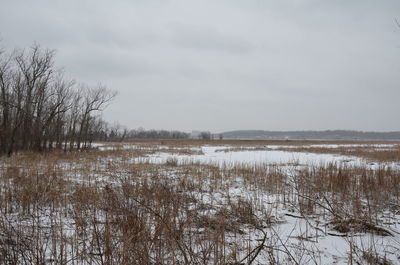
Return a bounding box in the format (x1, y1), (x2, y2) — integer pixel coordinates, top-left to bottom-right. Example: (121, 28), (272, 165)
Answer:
(0, 0), (400, 132)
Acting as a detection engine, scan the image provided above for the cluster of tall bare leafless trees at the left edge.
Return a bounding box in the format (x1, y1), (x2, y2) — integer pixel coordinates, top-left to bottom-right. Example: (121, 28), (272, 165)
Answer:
(0, 45), (115, 154)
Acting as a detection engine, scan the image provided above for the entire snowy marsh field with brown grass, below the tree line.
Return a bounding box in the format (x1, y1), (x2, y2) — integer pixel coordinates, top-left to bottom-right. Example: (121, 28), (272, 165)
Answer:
(0, 140), (400, 265)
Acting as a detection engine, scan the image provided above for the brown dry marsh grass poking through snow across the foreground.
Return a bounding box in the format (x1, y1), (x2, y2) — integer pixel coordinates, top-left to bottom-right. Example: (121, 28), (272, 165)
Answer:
(0, 141), (400, 264)
